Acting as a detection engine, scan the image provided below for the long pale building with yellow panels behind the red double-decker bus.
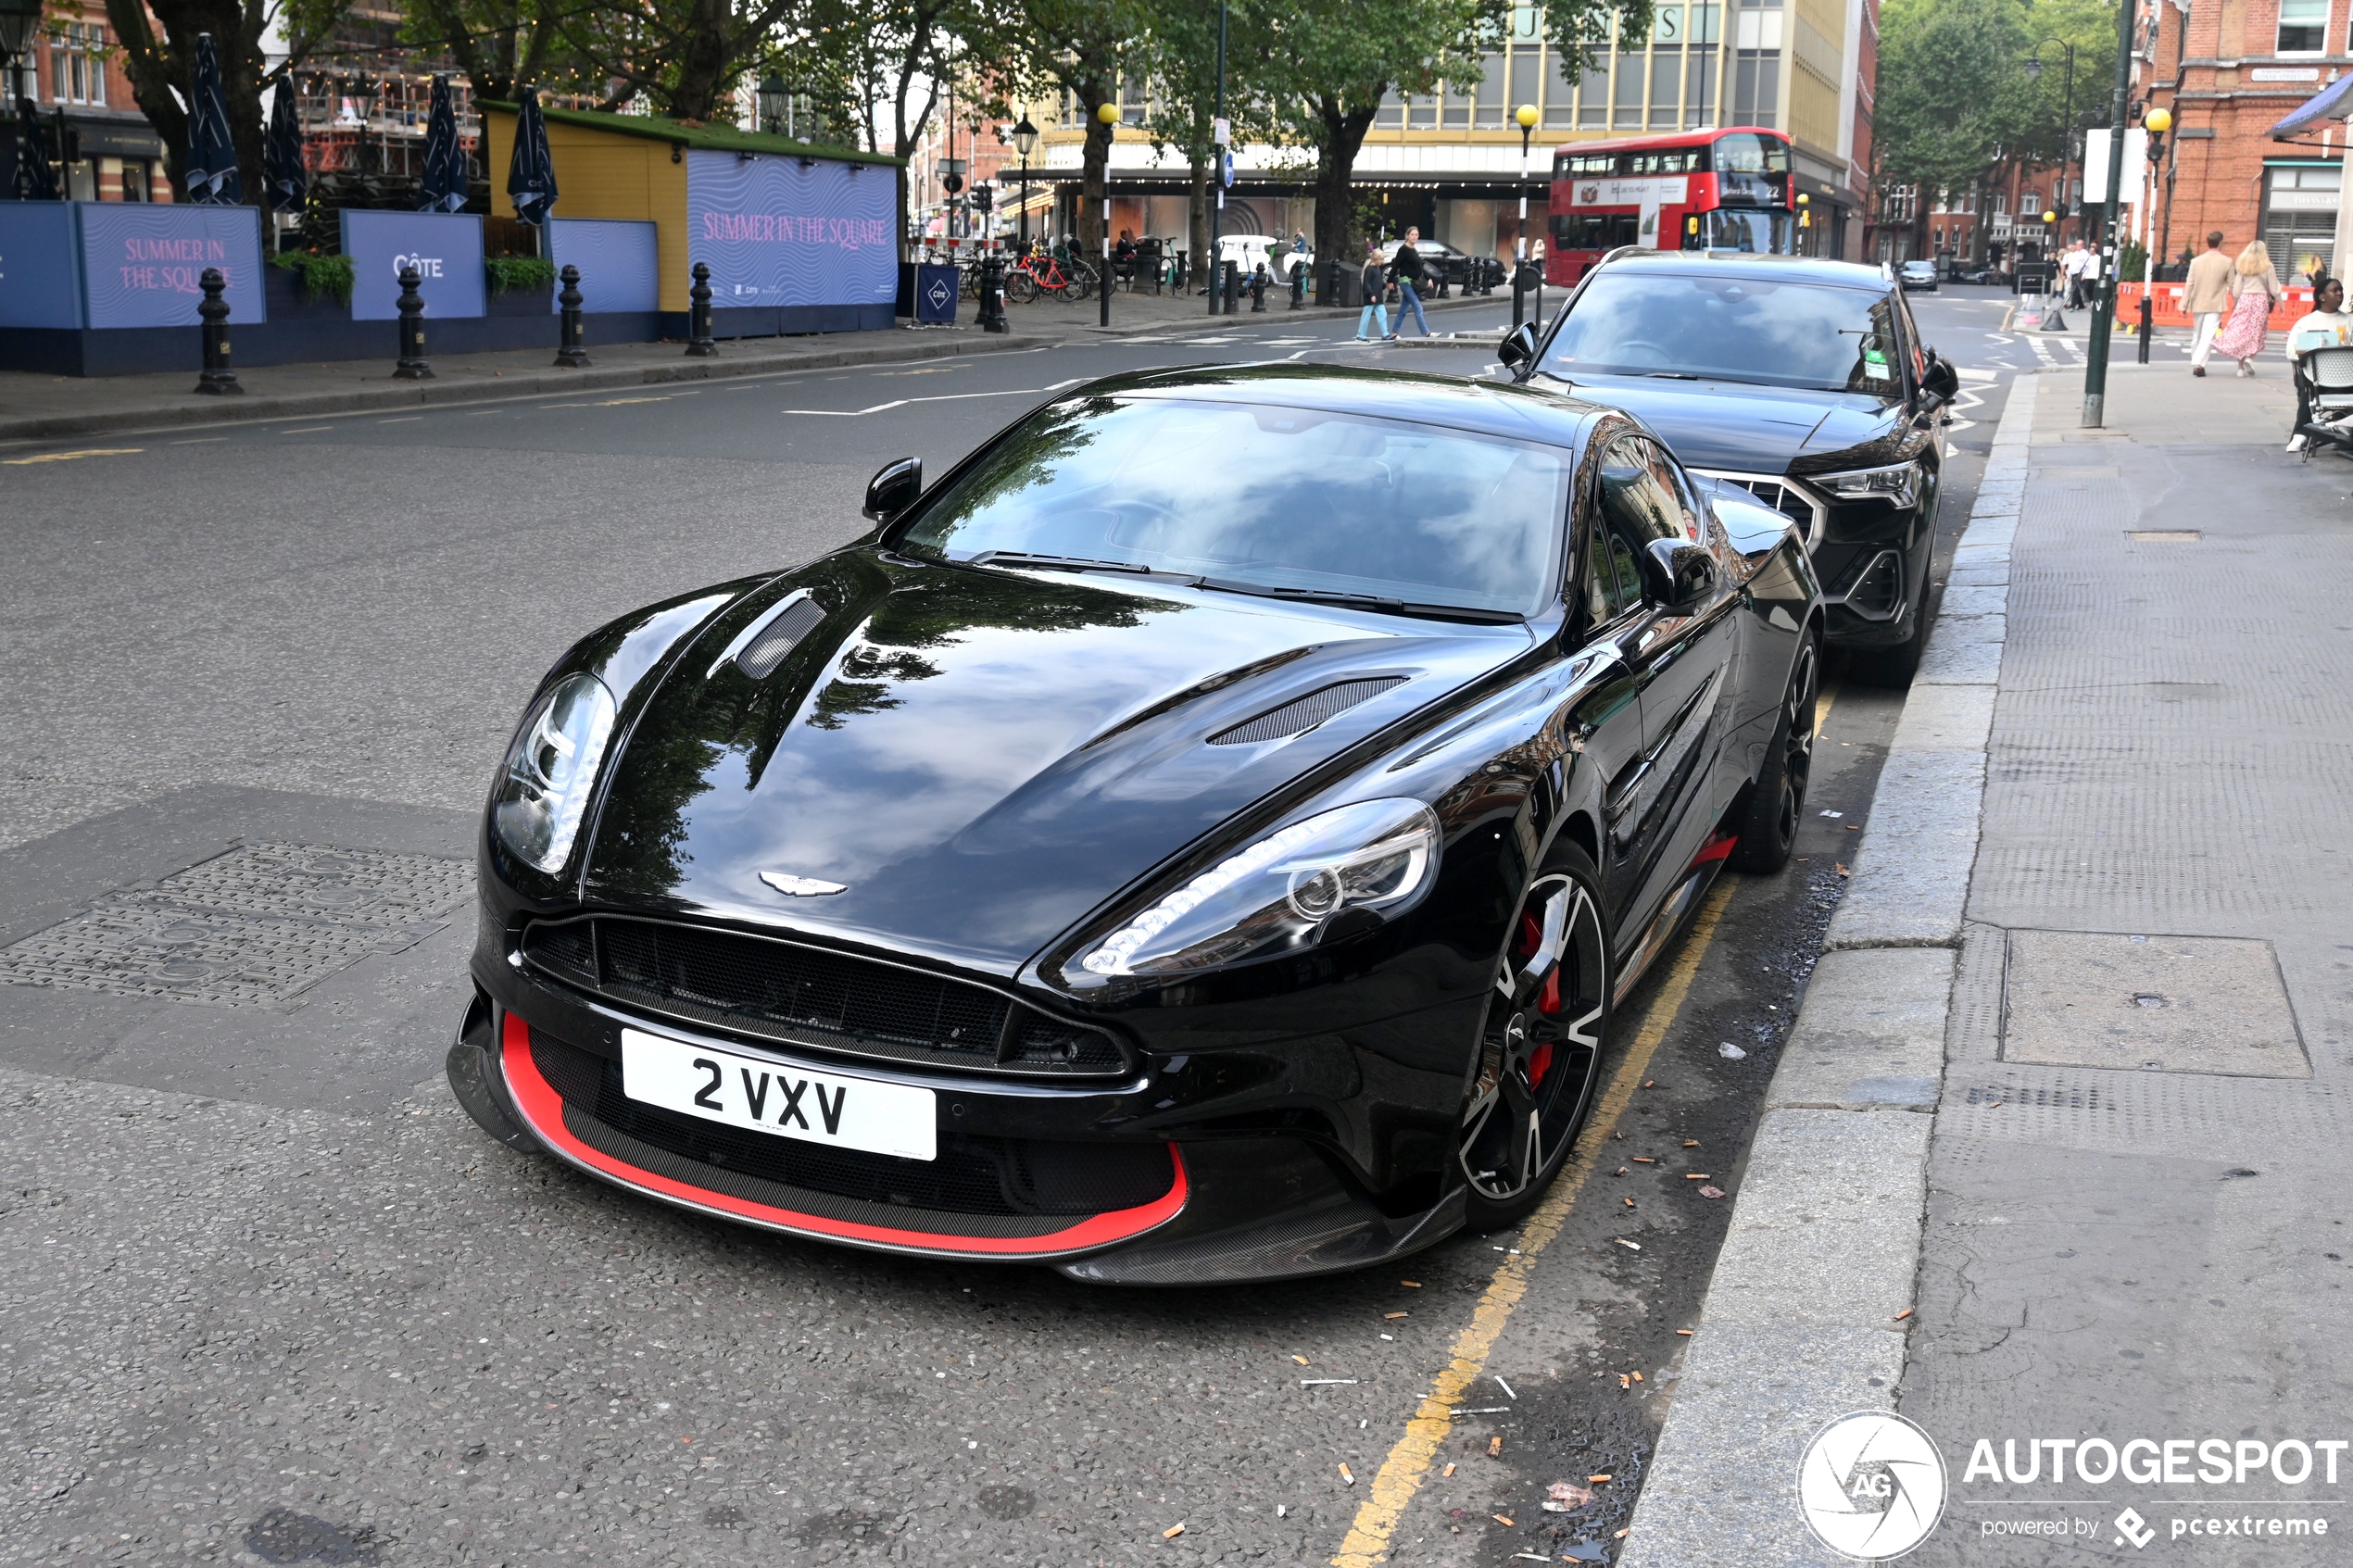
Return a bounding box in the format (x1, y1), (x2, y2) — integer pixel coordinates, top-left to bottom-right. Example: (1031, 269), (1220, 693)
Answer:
(1028, 0), (1878, 257)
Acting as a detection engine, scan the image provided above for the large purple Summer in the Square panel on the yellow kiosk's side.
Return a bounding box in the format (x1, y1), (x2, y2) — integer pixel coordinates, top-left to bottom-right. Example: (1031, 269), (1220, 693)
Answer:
(687, 153), (899, 310)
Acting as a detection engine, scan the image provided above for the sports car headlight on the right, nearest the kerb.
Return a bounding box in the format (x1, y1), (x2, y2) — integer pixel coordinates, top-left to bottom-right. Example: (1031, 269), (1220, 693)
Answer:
(1077, 799), (1438, 975)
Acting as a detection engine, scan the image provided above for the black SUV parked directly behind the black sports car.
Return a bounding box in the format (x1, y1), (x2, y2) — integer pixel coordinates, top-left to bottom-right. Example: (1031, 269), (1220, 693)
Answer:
(1504, 249), (1960, 684)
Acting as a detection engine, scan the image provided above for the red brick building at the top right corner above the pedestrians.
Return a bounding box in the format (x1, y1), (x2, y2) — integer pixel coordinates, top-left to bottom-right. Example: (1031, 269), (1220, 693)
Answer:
(2134, 0), (2353, 275)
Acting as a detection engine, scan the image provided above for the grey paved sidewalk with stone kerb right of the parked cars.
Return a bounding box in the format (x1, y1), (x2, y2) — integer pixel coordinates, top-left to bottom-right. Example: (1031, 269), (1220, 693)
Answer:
(1624, 355), (2353, 1568)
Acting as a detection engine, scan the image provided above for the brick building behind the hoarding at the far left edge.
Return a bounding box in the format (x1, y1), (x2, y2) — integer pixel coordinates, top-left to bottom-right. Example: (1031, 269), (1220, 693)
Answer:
(0, 0), (171, 202)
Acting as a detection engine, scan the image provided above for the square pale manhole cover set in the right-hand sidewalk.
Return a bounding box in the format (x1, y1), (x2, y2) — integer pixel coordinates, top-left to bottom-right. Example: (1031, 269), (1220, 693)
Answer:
(2003, 931), (2310, 1079)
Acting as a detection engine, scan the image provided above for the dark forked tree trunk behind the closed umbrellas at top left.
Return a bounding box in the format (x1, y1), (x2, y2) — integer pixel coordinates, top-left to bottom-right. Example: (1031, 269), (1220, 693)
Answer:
(106, 0), (350, 200)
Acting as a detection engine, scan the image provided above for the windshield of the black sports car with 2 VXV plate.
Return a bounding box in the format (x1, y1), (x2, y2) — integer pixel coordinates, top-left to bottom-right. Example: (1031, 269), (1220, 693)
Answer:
(899, 397), (1569, 619)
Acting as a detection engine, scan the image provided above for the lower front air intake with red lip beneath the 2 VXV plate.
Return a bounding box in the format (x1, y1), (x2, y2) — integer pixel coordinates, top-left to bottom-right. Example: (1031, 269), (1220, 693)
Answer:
(532, 1030), (1176, 1236)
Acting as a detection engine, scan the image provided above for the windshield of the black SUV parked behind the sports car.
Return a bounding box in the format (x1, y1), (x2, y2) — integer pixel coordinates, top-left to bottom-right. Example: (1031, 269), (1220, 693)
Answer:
(1541, 268), (1901, 397)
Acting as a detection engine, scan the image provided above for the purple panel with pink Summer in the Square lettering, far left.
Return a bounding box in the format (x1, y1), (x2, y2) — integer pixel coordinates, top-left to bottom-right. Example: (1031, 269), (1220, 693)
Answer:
(75, 202), (269, 327)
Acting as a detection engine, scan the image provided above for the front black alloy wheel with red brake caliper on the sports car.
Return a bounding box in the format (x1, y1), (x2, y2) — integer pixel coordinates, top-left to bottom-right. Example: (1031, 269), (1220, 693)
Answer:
(1459, 848), (1609, 1229)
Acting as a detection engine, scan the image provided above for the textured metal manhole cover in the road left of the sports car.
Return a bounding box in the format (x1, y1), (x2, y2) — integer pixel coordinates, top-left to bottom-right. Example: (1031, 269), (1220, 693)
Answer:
(0, 844), (473, 1009)
